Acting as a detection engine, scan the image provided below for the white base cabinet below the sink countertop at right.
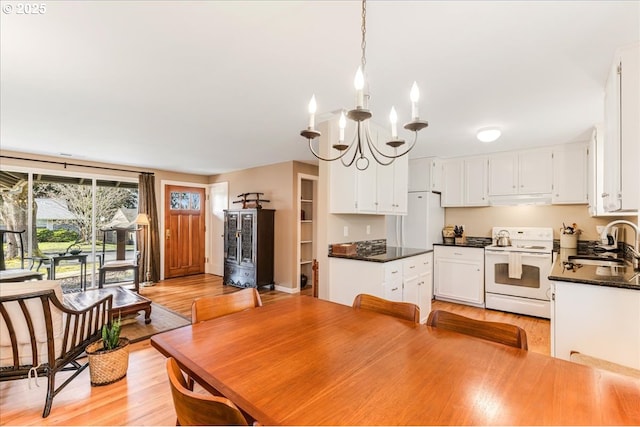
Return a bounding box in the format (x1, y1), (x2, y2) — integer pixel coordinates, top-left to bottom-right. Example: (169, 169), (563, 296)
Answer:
(551, 282), (640, 369)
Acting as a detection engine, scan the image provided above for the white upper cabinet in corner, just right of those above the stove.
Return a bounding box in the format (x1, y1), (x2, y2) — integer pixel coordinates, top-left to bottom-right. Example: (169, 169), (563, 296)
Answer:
(551, 143), (589, 204)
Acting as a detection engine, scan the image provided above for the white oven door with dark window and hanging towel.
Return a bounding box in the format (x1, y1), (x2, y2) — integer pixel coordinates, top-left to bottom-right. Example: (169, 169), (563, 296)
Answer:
(485, 250), (552, 301)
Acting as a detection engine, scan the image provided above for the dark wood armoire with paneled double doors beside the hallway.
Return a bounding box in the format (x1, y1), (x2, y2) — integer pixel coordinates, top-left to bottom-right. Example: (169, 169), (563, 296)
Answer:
(223, 209), (275, 290)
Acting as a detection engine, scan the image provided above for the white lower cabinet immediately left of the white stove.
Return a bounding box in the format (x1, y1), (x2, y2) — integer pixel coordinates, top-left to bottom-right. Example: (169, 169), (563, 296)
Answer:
(433, 245), (484, 307)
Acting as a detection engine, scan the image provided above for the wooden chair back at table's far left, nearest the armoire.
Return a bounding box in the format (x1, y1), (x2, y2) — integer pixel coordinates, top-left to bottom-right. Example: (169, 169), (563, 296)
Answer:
(191, 288), (262, 323)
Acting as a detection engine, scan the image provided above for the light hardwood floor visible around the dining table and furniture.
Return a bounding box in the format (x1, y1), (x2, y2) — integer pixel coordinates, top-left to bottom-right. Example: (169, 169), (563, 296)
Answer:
(0, 275), (550, 426)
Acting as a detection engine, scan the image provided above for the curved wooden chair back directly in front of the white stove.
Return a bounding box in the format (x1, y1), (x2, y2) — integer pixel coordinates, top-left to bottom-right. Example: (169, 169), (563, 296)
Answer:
(426, 310), (528, 350)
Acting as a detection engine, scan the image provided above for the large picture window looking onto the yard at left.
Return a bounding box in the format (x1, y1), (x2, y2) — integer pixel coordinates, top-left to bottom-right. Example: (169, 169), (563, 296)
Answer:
(0, 170), (138, 291)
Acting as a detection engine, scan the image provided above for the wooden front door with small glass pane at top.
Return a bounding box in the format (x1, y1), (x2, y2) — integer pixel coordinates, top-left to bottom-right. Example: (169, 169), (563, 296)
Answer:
(164, 185), (206, 279)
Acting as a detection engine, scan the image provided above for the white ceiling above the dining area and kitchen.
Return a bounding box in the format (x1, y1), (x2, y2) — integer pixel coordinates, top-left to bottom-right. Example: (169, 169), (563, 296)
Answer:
(0, 0), (640, 175)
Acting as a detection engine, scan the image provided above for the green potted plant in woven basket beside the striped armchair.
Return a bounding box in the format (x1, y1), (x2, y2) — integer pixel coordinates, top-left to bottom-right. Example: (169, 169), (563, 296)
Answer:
(86, 315), (129, 386)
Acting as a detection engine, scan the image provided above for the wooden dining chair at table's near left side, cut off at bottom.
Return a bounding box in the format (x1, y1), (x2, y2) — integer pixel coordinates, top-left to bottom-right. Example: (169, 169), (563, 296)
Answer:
(167, 357), (248, 426)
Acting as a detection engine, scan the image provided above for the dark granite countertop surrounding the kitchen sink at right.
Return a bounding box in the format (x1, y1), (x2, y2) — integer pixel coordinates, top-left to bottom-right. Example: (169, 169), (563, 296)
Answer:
(549, 249), (640, 291)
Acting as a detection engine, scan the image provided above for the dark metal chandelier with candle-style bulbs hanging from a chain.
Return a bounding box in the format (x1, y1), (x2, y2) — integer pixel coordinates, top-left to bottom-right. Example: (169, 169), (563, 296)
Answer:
(300, 0), (429, 170)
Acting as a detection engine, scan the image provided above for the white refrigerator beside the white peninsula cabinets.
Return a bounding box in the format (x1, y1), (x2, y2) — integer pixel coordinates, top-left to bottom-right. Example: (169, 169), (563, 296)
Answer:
(387, 191), (444, 249)
